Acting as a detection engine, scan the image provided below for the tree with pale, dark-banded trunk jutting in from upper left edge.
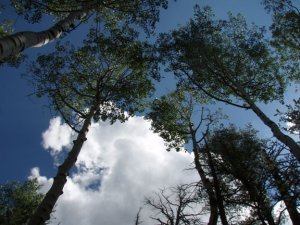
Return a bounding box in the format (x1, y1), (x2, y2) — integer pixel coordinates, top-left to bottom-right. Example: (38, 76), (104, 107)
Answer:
(0, 0), (168, 60)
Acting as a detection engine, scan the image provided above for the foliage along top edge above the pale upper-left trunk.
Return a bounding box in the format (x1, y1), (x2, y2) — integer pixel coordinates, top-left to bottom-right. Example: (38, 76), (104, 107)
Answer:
(11, 0), (168, 33)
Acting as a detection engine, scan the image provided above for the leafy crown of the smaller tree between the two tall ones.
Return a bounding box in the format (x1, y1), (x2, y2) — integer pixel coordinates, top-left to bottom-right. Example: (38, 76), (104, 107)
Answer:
(146, 87), (223, 151)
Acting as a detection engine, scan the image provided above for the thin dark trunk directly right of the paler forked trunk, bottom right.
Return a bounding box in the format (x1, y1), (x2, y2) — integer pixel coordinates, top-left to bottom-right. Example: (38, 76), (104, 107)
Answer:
(206, 145), (229, 225)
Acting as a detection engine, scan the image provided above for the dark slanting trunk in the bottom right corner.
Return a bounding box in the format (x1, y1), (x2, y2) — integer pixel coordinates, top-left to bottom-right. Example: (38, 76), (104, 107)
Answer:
(263, 152), (300, 225)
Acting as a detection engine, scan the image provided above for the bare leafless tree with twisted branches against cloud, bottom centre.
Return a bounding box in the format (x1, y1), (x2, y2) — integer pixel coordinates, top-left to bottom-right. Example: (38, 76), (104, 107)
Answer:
(145, 185), (201, 225)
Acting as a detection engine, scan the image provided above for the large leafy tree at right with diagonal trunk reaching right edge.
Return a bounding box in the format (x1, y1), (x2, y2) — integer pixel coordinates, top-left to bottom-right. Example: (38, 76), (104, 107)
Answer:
(158, 6), (300, 161)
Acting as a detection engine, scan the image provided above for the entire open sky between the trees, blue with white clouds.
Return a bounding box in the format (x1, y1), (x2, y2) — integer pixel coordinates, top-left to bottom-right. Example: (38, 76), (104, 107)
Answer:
(0, 0), (294, 225)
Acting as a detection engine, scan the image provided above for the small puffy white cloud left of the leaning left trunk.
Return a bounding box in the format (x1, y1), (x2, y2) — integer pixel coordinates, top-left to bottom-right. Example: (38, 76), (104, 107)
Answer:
(42, 117), (72, 154)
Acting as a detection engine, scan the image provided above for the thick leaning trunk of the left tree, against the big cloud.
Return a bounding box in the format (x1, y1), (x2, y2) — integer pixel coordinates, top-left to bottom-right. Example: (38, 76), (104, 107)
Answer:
(28, 107), (96, 225)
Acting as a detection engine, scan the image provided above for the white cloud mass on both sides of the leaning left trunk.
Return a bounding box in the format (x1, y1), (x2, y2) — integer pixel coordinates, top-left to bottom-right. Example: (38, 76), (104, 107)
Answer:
(32, 117), (199, 225)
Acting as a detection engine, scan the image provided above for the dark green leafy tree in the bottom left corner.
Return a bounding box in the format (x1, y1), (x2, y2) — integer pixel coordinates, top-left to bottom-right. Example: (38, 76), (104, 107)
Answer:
(0, 180), (43, 225)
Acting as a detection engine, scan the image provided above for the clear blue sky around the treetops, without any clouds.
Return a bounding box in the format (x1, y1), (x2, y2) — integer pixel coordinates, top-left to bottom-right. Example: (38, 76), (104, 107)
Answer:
(0, 0), (278, 182)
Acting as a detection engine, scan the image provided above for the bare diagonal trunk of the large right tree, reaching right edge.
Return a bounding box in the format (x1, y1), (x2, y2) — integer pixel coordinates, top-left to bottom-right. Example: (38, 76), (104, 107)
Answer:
(242, 92), (300, 162)
